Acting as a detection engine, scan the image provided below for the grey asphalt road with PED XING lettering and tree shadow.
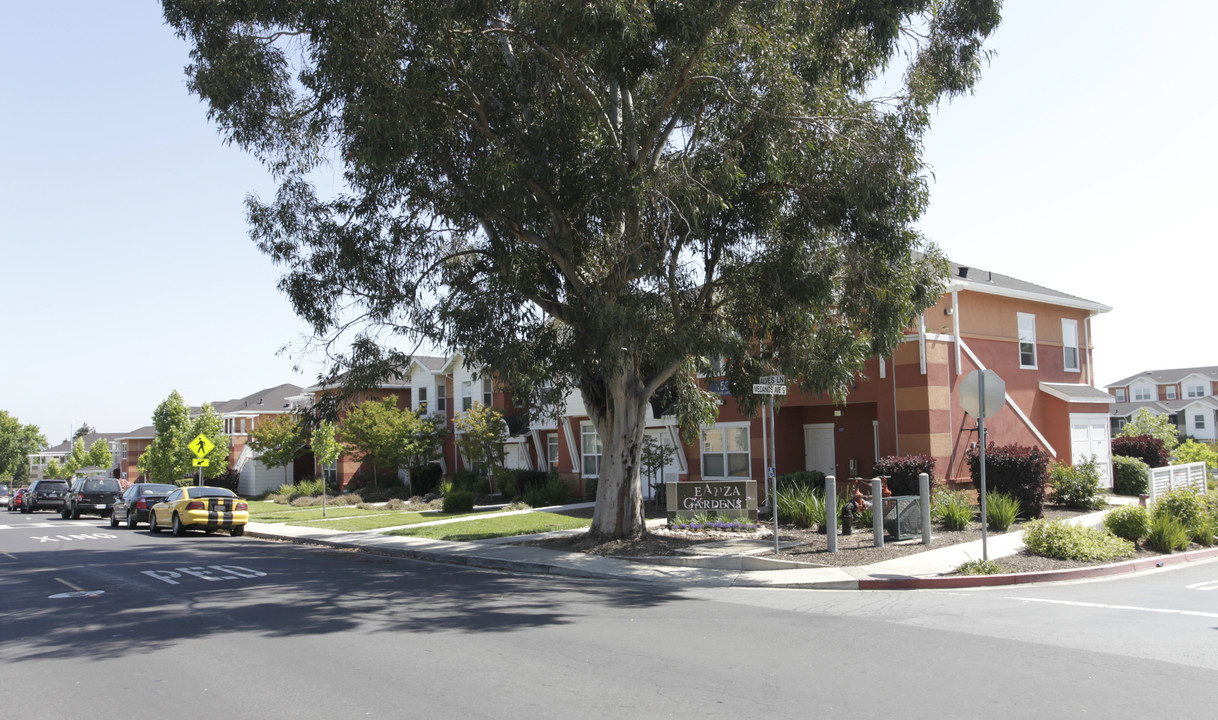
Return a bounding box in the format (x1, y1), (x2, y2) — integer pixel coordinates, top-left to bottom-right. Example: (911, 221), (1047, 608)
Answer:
(0, 513), (1218, 720)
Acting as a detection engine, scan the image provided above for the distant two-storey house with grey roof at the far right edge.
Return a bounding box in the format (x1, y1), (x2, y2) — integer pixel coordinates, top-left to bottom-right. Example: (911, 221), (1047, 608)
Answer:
(1106, 365), (1218, 442)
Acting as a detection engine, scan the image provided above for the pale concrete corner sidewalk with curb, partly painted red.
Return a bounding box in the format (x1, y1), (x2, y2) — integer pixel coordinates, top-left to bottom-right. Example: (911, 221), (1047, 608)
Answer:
(246, 501), (1218, 590)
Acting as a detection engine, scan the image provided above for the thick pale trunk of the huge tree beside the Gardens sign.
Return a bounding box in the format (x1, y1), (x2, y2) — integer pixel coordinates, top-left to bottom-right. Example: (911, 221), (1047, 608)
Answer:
(583, 369), (650, 540)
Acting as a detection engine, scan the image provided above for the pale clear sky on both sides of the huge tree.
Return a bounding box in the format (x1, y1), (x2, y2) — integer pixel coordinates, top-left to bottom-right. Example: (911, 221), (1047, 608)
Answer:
(0, 0), (1218, 442)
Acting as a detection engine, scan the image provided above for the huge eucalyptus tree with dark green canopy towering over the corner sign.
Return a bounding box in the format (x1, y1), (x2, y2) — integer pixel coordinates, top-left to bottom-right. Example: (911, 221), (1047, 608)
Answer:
(164, 0), (999, 537)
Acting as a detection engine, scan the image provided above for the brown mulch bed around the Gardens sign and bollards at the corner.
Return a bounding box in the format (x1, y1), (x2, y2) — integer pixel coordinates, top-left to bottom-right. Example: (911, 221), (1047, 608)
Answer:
(520, 506), (1188, 573)
